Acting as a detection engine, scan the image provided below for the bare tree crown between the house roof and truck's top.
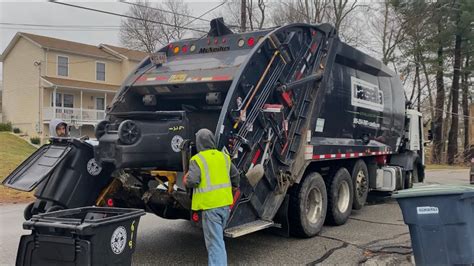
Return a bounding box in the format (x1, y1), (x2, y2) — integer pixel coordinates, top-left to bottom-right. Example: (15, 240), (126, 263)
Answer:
(120, 0), (190, 53)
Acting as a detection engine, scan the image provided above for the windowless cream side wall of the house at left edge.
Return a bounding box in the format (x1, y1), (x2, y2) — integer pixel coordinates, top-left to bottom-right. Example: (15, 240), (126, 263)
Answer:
(3, 38), (44, 136)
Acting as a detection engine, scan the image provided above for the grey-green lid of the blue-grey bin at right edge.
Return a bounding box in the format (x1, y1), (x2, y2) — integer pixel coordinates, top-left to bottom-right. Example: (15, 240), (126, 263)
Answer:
(392, 185), (474, 198)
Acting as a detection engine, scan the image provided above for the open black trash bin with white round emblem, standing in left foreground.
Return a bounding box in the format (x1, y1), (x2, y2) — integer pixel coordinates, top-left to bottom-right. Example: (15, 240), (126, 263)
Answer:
(16, 207), (145, 266)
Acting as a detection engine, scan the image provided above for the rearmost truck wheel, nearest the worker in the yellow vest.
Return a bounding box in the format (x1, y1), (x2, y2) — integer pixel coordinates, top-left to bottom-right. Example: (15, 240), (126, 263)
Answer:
(288, 172), (327, 237)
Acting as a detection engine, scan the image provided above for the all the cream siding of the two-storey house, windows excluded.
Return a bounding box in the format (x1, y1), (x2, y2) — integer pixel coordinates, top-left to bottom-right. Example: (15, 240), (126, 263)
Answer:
(0, 33), (144, 141)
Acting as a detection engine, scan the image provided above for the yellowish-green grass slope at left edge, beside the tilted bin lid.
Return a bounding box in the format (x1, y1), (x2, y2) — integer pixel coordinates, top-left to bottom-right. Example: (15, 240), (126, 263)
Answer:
(0, 132), (36, 203)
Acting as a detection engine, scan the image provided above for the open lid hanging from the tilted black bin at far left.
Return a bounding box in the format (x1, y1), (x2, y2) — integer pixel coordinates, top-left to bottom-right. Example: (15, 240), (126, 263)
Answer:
(2, 144), (71, 191)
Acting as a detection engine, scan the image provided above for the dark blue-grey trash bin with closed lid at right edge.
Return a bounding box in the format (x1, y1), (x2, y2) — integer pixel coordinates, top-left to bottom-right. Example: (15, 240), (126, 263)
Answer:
(393, 185), (474, 265)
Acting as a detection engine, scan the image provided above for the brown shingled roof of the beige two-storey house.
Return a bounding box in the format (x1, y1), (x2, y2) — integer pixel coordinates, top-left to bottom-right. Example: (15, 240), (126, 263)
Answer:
(0, 32), (146, 61)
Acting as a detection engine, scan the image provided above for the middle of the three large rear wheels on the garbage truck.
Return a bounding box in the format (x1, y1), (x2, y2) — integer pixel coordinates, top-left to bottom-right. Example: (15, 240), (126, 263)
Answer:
(326, 167), (354, 225)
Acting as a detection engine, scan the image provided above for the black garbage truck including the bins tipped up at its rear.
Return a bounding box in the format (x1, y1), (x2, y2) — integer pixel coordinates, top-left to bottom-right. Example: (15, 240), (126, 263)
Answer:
(3, 18), (424, 237)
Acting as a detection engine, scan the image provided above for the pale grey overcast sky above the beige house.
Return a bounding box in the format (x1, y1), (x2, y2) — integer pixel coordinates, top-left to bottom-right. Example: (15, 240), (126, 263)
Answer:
(0, 0), (224, 79)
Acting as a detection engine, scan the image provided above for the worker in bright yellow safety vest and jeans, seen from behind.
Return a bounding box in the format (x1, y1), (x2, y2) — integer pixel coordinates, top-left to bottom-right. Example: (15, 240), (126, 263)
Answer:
(184, 129), (240, 265)
